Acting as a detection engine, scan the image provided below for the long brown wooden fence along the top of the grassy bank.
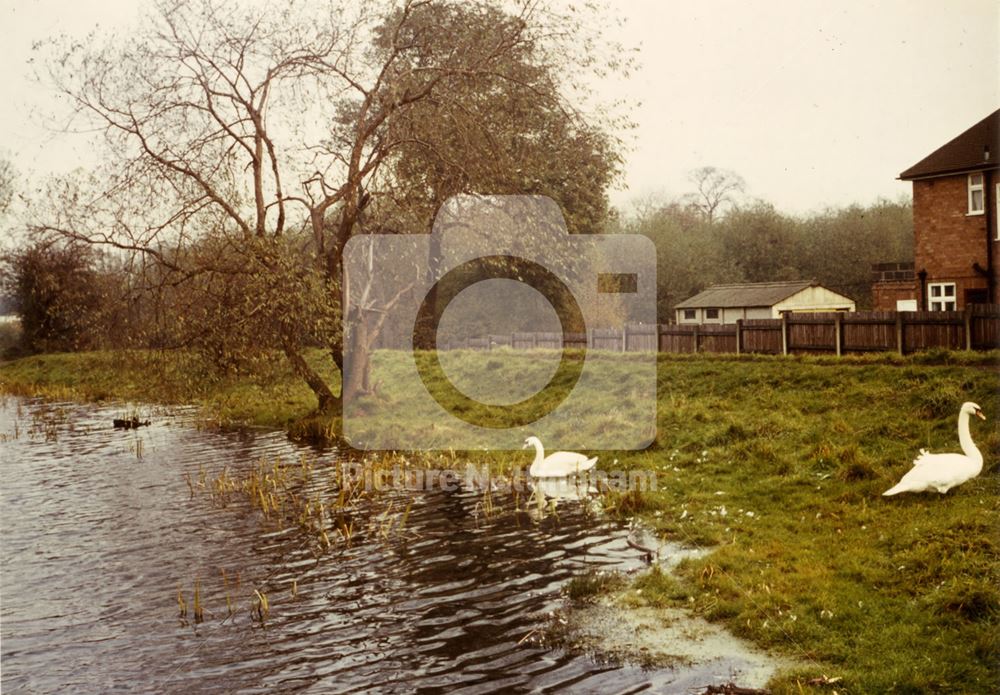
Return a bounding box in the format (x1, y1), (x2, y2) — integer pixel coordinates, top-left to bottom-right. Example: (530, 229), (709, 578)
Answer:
(439, 304), (1000, 355)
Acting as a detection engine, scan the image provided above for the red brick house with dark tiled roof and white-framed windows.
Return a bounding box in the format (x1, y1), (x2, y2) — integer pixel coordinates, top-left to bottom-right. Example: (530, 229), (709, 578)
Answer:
(872, 110), (1000, 311)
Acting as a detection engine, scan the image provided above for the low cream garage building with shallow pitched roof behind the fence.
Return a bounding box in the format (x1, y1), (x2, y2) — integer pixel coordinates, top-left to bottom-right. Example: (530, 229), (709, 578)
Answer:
(674, 280), (855, 324)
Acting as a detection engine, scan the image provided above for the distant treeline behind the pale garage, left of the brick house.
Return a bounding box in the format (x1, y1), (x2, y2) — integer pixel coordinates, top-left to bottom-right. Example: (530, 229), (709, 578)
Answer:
(620, 193), (913, 323)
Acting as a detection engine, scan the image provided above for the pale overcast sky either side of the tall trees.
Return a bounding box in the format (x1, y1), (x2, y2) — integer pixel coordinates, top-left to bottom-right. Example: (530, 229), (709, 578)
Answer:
(0, 0), (1000, 213)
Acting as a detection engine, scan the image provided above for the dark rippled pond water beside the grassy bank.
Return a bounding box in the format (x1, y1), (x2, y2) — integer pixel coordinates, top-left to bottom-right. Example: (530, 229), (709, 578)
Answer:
(0, 398), (764, 693)
